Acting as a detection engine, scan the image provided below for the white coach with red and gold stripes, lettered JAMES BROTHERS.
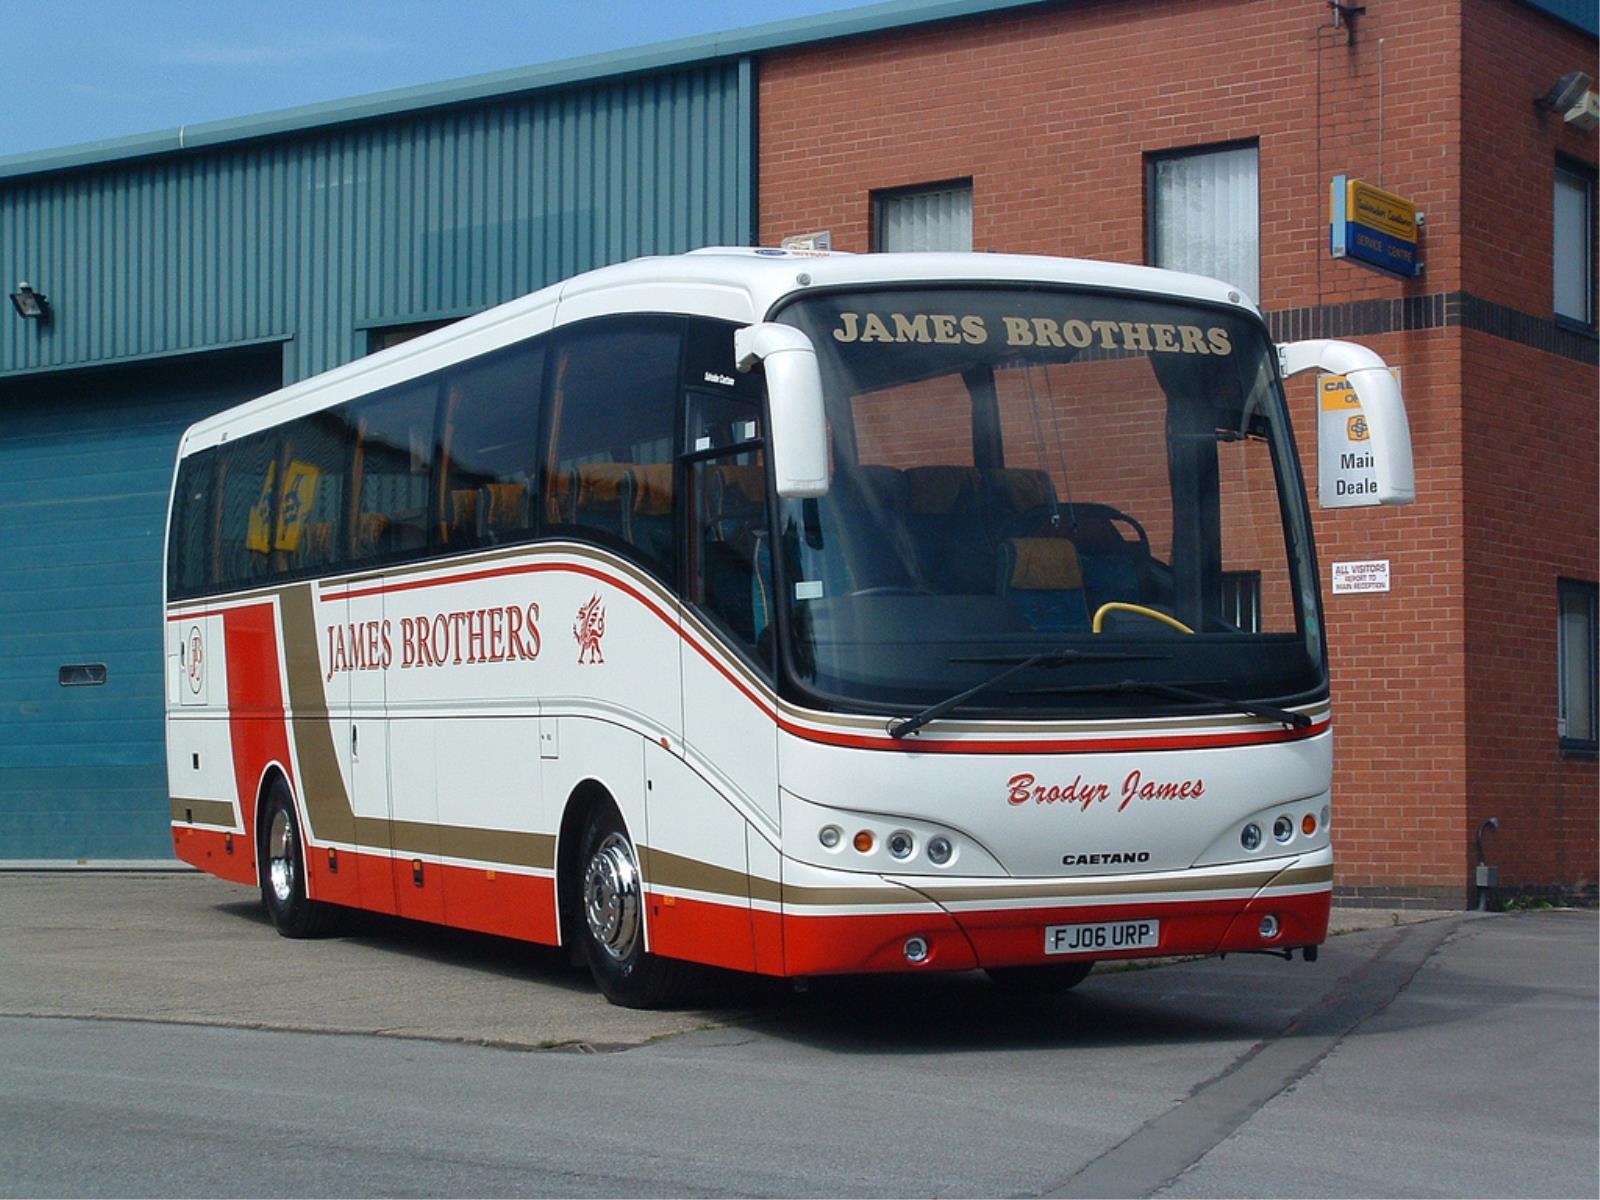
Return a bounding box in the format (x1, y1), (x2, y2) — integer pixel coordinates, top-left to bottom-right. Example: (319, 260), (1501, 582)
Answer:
(165, 248), (1413, 1006)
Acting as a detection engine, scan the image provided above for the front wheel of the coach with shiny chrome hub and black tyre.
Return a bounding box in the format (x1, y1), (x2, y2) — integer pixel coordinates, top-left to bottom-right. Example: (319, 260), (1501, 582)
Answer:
(574, 803), (690, 1008)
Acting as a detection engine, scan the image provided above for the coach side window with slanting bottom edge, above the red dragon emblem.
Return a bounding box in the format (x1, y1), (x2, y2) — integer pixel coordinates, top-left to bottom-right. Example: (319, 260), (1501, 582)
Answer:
(542, 317), (683, 581)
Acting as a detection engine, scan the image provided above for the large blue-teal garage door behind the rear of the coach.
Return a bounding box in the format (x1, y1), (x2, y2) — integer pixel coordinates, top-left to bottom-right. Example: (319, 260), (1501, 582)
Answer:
(0, 346), (282, 862)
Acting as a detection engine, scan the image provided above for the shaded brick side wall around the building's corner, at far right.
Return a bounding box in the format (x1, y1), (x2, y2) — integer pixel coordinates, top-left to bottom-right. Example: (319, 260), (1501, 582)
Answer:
(1461, 0), (1600, 890)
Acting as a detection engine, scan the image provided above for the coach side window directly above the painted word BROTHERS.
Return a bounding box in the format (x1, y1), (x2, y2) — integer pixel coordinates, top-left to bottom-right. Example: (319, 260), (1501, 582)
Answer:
(435, 336), (544, 550)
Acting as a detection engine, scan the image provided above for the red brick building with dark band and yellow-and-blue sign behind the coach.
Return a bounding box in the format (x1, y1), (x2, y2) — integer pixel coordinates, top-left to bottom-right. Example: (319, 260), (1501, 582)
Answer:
(758, 0), (1600, 906)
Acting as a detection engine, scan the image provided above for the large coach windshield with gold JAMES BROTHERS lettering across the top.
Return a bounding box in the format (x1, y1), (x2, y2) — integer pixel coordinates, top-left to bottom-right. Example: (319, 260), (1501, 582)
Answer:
(774, 285), (1326, 718)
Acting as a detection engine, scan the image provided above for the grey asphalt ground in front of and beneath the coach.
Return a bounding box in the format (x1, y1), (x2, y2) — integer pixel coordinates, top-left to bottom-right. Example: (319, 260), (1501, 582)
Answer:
(0, 877), (1600, 1197)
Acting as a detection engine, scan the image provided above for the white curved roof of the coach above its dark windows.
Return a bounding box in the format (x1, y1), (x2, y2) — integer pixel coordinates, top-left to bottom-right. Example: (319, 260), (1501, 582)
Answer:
(179, 246), (1259, 454)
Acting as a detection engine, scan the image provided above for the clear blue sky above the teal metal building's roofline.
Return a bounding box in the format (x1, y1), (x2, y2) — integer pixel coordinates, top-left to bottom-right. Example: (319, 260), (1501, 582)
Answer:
(0, 0), (862, 158)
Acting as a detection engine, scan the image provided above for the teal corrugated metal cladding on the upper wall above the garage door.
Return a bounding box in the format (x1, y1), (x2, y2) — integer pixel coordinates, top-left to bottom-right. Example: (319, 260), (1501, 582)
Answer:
(0, 59), (755, 382)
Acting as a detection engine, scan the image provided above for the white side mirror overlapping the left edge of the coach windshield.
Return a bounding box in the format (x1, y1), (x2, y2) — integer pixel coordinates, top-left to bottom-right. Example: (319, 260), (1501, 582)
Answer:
(733, 322), (827, 499)
